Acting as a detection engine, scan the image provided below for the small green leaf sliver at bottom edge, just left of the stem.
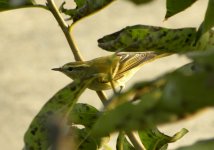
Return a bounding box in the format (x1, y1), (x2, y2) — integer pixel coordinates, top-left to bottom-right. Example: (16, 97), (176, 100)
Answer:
(116, 132), (135, 150)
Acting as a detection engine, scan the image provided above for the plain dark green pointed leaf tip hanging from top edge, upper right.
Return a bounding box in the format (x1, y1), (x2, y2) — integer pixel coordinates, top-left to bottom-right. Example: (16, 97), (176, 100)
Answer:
(165, 0), (197, 19)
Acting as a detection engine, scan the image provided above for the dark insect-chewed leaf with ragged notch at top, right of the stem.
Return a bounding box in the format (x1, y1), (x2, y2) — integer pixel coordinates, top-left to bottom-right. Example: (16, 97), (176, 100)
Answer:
(60, 0), (114, 22)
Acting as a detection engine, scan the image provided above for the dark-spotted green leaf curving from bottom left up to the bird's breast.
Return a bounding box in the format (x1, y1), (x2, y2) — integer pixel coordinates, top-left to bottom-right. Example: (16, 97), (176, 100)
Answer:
(24, 79), (92, 150)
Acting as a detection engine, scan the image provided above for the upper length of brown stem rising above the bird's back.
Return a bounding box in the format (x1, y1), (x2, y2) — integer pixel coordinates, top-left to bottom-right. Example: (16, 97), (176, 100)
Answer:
(47, 0), (83, 61)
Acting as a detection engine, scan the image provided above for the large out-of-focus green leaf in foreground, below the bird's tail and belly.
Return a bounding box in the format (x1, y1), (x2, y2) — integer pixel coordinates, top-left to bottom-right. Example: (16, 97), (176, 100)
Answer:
(92, 50), (214, 137)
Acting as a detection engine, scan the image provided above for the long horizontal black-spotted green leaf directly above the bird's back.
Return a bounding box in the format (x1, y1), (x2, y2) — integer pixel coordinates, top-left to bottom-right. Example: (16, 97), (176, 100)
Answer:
(98, 25), (210, 53)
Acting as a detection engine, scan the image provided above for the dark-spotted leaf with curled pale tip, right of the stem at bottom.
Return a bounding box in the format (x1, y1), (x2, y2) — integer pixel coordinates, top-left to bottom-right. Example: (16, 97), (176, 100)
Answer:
(138, 127), (188, 150)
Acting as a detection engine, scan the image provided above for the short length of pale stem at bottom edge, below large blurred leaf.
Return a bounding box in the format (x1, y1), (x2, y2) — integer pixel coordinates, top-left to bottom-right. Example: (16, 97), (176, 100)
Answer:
(126, 132), (145, 150)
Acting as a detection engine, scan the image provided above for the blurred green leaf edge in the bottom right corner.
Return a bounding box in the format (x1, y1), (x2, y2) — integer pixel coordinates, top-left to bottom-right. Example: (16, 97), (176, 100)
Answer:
(176, 139), (214, 150)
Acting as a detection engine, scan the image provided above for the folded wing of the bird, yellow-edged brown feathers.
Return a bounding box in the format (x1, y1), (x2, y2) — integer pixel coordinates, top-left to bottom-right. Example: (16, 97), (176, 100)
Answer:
(113, 52), (157, 80)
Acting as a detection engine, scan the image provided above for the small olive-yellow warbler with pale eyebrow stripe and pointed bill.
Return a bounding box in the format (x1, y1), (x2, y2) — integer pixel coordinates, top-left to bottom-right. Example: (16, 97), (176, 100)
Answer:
(52, 52), (165, 91)
